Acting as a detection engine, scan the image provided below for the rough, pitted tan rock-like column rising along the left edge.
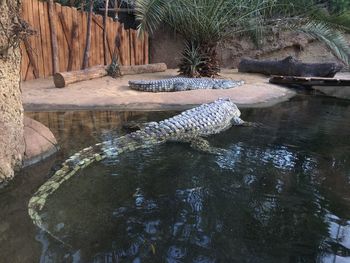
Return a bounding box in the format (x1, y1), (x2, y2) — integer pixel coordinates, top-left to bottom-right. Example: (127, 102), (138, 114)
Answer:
(0, 0), (25, 183)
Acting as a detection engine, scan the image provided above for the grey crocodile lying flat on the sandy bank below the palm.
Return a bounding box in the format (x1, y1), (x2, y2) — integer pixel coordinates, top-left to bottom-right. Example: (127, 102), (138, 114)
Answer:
(129, 77), (244, 92)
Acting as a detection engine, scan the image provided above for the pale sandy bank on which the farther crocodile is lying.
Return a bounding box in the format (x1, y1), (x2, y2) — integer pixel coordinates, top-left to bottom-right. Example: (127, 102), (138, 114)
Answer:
(22, 69), (295, 111)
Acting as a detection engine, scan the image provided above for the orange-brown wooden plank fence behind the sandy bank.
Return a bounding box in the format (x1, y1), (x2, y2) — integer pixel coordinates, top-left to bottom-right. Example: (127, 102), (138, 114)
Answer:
(21, 0), (148, 80)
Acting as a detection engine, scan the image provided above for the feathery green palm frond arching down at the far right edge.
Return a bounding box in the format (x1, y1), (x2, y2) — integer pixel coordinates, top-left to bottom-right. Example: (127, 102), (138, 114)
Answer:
(298, 21), (350, 65)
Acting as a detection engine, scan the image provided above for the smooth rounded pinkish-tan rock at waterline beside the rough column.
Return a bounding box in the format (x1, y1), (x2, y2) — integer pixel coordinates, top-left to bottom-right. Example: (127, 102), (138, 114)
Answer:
(23, 117), (58, 167)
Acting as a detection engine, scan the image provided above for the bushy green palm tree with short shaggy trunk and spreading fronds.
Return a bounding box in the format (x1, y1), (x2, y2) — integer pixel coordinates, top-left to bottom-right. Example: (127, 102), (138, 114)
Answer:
(135, 0), (350, 77)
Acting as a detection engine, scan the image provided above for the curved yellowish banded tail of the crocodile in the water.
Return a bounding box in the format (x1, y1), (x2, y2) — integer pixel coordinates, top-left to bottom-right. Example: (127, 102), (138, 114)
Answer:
(28, 142), (110, 245)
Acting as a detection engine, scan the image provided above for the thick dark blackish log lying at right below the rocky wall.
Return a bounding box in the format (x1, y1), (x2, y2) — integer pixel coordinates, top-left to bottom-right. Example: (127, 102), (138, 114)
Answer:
(238, 56), (343, 78)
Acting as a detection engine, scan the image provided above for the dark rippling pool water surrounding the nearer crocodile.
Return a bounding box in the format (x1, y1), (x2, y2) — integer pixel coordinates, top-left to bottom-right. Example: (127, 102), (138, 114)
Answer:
(0, 97), (350, 263)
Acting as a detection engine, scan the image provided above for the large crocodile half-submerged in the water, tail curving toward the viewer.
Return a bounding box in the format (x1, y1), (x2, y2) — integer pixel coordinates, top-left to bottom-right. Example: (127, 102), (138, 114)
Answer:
(28, 99), (245, 245)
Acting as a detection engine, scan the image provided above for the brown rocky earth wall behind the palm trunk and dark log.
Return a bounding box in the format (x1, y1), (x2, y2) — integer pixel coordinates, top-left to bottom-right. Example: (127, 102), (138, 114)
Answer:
(150, 27), (348, 68)
